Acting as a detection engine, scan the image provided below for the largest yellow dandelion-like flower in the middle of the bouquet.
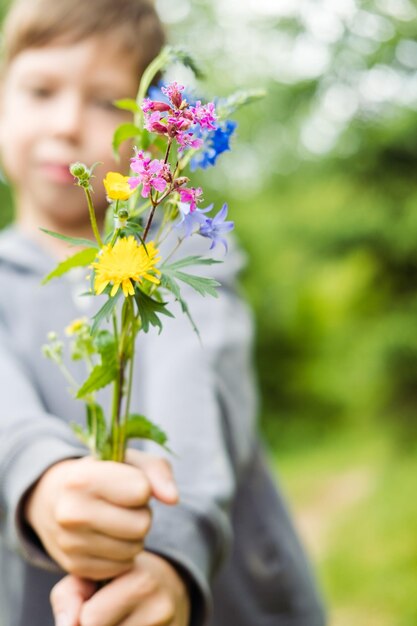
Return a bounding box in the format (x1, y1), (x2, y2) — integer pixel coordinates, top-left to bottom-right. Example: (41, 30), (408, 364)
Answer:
(92, 235), (161, 298)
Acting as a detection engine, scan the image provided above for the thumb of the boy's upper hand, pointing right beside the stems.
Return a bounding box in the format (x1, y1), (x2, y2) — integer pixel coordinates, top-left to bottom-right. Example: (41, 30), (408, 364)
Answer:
(126, 448), (179, 504)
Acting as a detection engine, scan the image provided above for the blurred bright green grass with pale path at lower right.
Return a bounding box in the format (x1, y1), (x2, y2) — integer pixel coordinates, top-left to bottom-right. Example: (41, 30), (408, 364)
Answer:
(276, 426), (417, 626)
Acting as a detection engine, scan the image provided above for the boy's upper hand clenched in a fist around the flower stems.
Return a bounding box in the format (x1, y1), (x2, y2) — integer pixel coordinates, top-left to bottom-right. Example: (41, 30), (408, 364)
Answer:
(24, 450), (178, 580)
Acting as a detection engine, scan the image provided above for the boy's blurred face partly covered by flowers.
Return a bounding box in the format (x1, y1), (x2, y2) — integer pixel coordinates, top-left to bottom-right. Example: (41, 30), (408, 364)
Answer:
(0, 36), (138, 228)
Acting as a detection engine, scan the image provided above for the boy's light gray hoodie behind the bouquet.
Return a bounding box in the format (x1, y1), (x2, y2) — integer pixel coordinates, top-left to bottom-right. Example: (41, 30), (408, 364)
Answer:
(0, 227), (325, 626)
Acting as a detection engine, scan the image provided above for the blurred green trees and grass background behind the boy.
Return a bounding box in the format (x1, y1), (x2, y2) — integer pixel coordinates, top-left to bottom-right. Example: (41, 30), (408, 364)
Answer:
(0, 0), (417, 626)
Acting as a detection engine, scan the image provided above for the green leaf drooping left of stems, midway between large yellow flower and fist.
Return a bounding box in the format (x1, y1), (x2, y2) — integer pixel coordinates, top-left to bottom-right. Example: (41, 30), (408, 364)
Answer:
(76, 330), (119, 399)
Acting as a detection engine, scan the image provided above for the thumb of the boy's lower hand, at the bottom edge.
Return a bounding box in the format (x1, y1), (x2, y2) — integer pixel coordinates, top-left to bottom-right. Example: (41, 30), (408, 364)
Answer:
(50, 576), (97, 626)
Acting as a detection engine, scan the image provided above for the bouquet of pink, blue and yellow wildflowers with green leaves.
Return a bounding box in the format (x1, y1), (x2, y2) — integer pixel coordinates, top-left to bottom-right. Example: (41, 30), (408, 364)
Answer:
(44, 48), (264, 461)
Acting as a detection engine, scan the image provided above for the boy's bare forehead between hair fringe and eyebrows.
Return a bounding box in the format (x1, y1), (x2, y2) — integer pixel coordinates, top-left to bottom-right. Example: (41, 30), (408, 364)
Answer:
(9, 36), (139, 91)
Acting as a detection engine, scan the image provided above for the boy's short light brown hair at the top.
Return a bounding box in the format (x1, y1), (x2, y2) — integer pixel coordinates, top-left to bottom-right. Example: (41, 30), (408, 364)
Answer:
(3, 0), (165, 76)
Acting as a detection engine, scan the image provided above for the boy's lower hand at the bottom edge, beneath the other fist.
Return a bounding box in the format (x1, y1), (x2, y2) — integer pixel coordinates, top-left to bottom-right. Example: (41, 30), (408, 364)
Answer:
(51, 551), (190, 626)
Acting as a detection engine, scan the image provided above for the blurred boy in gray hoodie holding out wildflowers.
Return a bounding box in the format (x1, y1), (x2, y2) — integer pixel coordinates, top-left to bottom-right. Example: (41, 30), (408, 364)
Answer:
(0, 0), (324, 626)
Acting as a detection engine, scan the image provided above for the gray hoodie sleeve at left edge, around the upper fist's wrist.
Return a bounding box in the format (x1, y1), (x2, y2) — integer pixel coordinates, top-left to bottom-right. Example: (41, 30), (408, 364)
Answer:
(0, 319), (86, 569)
